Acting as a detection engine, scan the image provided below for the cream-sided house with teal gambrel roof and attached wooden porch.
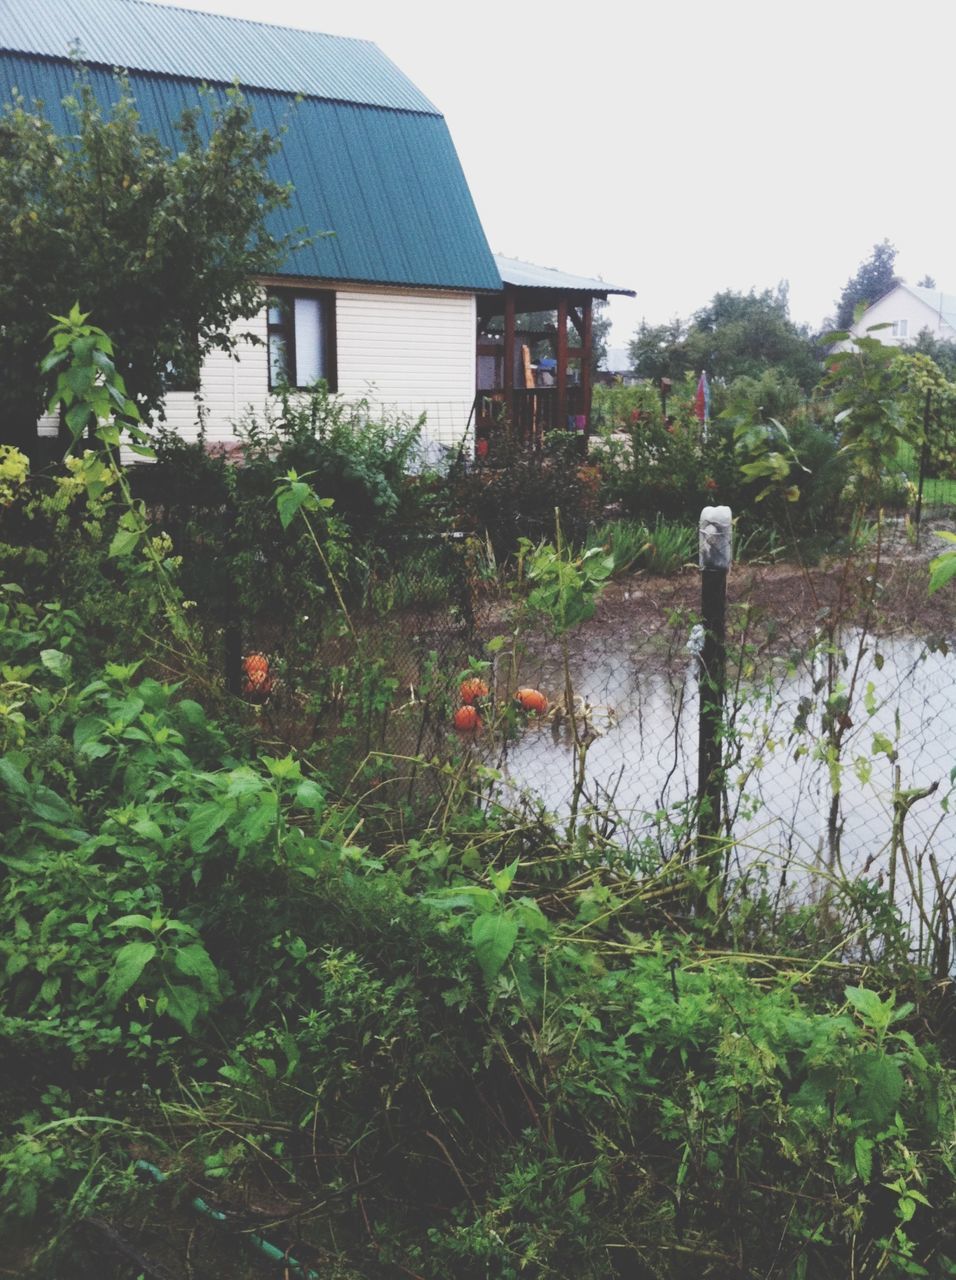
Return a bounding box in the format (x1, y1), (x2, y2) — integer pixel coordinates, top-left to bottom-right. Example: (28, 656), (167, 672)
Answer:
(0, 0), (630, 458)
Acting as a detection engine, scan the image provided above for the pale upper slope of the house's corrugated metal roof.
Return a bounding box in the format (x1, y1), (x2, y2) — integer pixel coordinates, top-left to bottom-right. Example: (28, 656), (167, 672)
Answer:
(0, 0), (440, 115)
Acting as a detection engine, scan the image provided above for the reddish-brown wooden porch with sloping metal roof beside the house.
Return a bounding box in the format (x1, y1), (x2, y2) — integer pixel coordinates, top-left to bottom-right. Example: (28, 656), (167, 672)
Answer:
(475, 255), (635, 456)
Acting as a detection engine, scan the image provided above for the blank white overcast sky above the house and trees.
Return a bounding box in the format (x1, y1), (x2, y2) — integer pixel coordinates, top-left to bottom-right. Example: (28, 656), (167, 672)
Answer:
(149, 0), (956, 346)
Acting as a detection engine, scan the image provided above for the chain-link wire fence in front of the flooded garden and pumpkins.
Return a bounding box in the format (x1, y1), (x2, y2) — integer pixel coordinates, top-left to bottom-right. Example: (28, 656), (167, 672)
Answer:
(145, 468), (956, 928)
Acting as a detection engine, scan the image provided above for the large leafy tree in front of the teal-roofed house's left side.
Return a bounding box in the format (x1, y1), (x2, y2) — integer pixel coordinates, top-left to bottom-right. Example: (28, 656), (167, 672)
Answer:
(0, 68), (299, 452)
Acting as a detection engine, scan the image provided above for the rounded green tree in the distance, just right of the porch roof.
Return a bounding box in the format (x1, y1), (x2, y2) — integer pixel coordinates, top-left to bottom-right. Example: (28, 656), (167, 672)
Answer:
(630, 284), (820, 390)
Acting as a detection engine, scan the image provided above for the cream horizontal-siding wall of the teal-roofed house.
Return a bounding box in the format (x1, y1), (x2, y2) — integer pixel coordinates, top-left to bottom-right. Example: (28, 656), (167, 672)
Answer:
(104, 288), (476, 460)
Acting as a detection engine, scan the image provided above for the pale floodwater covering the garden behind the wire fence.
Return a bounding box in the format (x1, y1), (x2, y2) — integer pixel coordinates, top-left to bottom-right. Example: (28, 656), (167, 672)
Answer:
(498, 636), (956, 901)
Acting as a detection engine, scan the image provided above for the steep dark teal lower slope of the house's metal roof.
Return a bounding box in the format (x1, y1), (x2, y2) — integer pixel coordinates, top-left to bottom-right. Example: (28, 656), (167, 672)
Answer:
(0, 8), (502, 292)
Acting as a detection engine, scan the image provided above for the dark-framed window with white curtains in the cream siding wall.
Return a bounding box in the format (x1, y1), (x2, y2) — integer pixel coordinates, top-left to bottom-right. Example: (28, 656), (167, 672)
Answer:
(267, 289), (335, 390)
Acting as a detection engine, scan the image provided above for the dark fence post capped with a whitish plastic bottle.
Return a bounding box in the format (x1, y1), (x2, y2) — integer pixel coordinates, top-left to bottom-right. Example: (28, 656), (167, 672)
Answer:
(697, 507), (732, 856)
